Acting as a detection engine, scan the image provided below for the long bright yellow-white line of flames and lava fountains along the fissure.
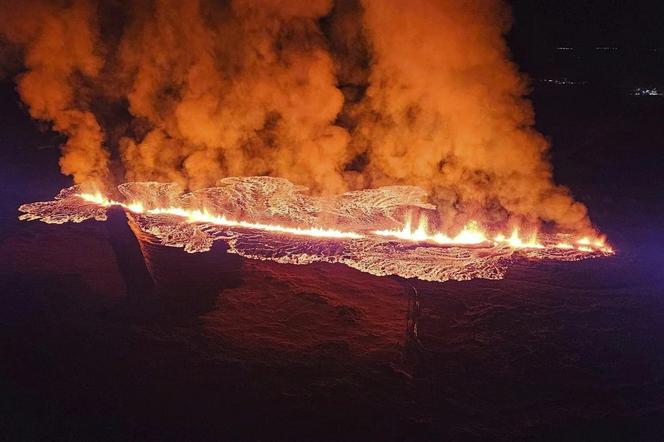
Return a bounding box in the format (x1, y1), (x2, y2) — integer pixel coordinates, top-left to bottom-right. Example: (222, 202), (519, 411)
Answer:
(78, 192), (614, 254)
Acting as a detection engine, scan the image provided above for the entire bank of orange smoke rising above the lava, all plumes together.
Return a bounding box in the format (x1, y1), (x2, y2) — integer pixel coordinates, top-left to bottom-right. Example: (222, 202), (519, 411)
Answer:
(0, 0), (590, 230)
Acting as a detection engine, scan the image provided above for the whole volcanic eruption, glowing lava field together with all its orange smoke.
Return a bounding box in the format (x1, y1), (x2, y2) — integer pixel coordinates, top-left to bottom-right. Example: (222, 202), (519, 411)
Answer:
(5, 0), (612, 281)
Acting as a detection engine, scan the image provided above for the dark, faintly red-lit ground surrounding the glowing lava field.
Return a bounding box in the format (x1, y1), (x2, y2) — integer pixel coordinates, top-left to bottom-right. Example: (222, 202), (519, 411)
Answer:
(0, 49), (664, 441)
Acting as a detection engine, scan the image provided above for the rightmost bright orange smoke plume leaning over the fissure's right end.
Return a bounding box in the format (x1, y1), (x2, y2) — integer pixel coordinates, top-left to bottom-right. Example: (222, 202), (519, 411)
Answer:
(354, 0), (587, 231)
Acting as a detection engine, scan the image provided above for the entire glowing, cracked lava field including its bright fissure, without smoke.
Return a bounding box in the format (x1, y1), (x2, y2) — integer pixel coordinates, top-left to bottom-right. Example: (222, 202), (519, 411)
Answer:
(19, 177), (614, 281)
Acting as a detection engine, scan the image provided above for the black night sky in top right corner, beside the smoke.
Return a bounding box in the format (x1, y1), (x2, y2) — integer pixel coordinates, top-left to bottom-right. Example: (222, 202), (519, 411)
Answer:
(508, 0), (664, 87)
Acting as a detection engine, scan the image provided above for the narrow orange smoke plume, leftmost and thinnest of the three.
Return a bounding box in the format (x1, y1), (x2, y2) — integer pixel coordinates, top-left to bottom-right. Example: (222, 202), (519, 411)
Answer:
(0, 1), (109, 183)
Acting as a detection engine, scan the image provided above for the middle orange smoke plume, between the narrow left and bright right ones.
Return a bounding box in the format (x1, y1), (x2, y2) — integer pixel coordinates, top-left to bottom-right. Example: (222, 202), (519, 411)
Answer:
(119, 0), (349, 191)
